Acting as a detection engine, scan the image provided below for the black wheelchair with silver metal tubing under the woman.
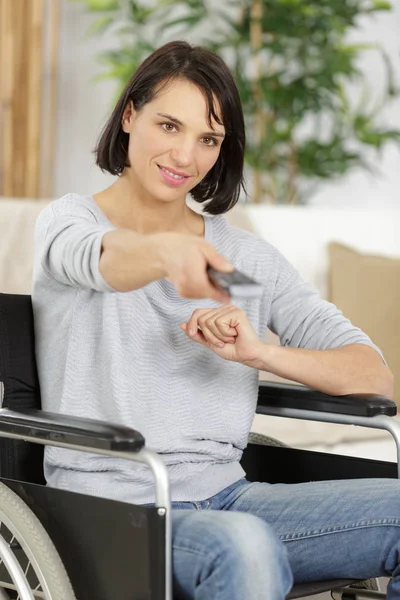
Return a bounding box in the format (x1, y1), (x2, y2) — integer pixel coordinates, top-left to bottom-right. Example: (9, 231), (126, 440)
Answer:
(0, 294), (400, 600)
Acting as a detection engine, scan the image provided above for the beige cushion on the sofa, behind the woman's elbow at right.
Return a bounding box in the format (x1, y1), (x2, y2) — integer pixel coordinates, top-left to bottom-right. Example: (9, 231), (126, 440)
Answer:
(329, 242), (400, 406)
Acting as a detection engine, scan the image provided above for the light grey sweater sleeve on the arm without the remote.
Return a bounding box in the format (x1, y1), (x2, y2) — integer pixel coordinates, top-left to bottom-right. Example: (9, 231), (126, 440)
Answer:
(268, 246), (383, 358)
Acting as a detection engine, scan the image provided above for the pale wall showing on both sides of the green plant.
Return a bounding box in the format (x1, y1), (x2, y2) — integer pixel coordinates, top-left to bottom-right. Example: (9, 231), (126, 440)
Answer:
(54, 0), (400, 207)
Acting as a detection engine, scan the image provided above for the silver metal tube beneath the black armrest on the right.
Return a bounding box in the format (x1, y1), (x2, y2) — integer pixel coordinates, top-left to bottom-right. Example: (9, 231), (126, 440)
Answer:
(257, 406), (400, 478)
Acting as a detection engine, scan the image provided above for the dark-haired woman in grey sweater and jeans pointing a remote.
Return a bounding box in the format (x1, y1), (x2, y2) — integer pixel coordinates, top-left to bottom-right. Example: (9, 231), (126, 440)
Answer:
(33, 42), (400, 600)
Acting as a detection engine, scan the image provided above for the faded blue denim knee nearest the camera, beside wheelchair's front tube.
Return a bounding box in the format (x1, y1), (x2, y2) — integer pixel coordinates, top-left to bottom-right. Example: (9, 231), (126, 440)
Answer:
(172, 510), (292, 600)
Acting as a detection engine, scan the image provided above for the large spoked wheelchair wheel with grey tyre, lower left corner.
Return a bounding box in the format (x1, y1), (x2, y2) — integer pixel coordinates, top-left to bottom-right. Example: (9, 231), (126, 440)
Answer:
(0, 483), (76, 600)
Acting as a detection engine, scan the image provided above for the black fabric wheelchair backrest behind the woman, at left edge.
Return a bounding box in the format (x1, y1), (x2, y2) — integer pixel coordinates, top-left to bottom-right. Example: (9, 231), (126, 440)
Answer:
(0, 294), (44, 483)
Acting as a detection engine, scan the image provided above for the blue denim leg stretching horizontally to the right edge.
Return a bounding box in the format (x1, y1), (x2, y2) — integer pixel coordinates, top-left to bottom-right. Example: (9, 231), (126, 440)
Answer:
(224, 479), (400, 600)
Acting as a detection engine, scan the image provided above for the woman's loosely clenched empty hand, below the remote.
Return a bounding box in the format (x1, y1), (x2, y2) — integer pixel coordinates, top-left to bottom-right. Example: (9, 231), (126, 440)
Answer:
(180, 304), (264, 366)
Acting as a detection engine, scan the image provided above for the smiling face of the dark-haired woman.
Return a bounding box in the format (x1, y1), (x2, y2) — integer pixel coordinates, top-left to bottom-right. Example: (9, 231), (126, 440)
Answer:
(122, 79), (225, 202)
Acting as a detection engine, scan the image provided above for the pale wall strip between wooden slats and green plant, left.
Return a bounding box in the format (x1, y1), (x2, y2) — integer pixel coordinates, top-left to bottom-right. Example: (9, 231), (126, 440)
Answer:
(54, 0), (115, 198)
